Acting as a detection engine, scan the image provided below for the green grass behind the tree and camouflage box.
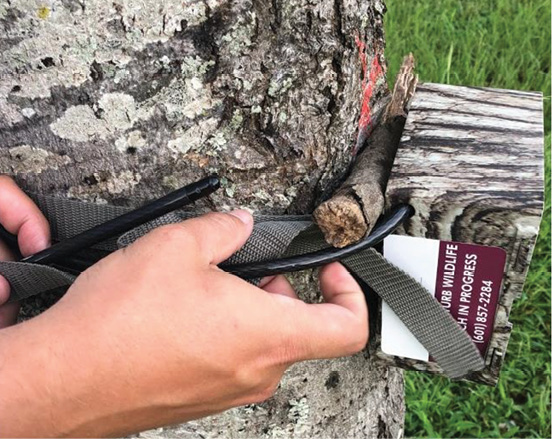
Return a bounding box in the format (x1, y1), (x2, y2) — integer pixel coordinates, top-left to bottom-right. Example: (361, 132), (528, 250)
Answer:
(385, 0), (551, 438)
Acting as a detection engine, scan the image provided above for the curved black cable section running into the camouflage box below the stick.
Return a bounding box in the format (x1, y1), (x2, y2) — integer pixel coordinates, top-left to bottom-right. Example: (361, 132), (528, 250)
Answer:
(219, 204), (414, 279)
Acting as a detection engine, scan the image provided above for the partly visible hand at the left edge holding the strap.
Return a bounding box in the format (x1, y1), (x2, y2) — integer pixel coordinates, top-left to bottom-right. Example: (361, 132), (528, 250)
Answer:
(0, 175), (50, 329)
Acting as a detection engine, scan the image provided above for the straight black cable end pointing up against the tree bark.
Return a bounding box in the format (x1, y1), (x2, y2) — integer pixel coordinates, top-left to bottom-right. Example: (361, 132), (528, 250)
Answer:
(21, 175), (220, 265)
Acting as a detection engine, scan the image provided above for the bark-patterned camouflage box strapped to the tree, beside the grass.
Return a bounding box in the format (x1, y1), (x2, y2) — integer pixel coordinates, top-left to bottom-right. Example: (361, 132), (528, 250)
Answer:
(378, 84), (543, 384)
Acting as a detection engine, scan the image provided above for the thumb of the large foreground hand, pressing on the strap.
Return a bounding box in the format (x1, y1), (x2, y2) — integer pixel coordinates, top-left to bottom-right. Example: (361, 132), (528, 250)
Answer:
(182, 210), (253, 264)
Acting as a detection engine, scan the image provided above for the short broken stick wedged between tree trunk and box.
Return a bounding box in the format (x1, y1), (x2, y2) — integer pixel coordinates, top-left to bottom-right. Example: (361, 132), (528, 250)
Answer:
(314, 54), (417, 247)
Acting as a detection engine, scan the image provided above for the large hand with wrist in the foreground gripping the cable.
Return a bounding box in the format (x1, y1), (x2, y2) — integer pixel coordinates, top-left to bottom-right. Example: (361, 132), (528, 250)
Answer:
(0, 211), (368, 436)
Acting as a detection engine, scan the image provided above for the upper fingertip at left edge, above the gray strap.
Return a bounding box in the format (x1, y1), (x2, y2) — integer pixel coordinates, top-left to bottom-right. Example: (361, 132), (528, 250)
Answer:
(0, 175), (50, 256)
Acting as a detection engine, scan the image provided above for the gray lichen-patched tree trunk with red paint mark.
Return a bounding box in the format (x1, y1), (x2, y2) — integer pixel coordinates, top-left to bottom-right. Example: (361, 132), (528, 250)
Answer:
(0, 0), (404, 437)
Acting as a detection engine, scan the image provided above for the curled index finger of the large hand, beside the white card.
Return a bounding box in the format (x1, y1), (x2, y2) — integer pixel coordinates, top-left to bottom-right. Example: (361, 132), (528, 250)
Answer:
(285, 263), (368, 361)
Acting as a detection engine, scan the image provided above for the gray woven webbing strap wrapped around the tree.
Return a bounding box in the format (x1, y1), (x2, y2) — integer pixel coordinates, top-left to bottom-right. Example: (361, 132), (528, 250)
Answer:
(0, 196), (484, 378)
